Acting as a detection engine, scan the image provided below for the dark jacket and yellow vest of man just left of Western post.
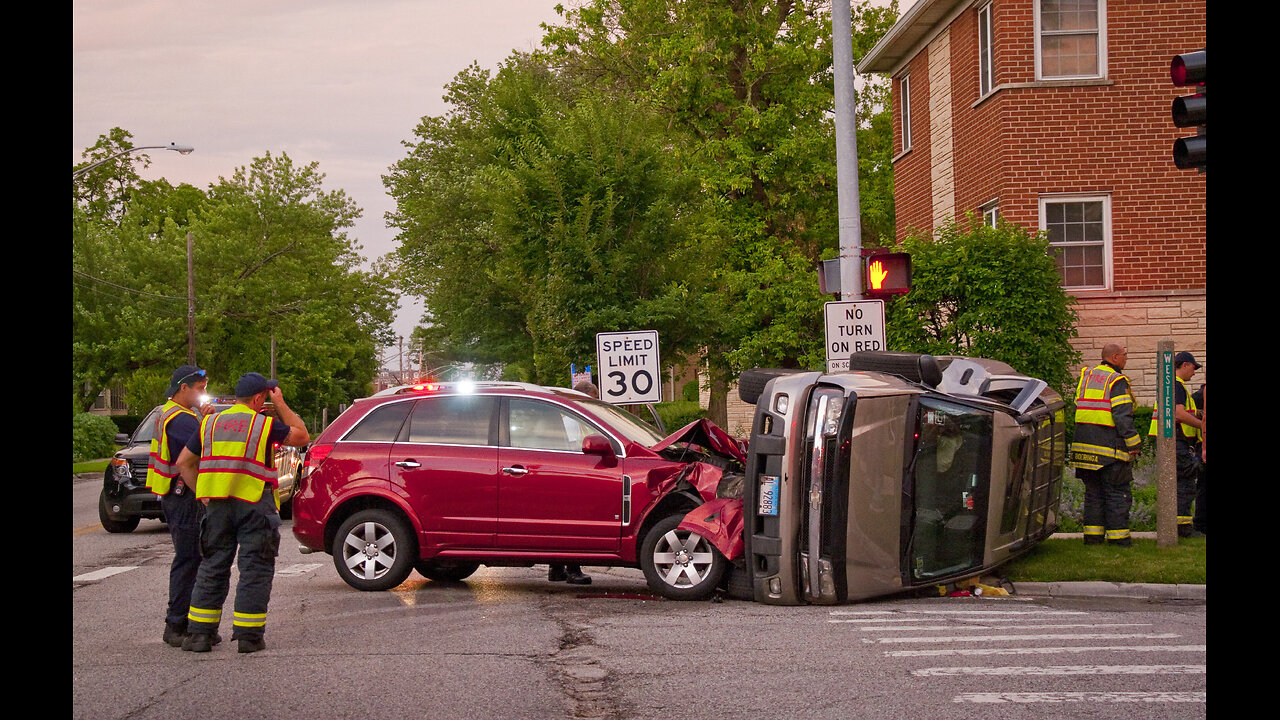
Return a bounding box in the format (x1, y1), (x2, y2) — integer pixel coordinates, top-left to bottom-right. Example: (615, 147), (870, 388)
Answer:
(1070, 364), (1142, 470)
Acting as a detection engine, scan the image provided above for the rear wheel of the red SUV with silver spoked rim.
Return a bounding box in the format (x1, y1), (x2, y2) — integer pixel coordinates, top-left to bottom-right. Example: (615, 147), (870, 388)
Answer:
(333, 507), (417, 591)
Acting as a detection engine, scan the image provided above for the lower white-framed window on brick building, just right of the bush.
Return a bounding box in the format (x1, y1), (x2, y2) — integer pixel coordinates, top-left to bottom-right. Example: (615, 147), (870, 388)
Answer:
(1039, 195), (1111, 290)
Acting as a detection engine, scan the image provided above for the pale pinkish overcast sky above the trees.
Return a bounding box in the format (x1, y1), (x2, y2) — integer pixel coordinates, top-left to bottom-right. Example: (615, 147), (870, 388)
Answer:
(72, 0), (571, 348)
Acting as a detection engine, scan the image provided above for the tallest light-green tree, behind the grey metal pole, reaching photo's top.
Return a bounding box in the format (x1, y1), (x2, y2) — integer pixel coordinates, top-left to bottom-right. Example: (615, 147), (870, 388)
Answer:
(544, 0), (897, 420)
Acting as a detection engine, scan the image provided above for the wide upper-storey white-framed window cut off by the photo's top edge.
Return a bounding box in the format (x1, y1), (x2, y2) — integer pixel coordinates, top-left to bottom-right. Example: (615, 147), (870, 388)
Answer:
(1036, 0), (1106, 79)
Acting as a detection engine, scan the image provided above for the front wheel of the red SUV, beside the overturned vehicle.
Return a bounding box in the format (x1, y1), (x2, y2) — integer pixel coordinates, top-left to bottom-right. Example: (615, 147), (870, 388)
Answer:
(640, 514), (728, 600)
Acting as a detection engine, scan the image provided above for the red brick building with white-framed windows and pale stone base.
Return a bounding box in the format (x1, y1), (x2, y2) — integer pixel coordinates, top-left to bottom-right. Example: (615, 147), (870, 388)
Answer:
(858, 0), (1207, 405)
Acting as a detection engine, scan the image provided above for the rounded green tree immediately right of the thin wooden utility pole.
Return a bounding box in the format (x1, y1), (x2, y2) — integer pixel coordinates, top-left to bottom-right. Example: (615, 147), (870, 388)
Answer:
(191, 152), (397, 413)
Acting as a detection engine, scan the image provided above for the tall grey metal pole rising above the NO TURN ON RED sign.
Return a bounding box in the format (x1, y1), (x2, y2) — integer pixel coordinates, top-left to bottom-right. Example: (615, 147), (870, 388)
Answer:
(831, 0), (863, 300)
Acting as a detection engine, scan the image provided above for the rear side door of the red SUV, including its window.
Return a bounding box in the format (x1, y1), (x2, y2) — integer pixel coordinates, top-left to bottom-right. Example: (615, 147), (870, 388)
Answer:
(390, 395), (498, 545)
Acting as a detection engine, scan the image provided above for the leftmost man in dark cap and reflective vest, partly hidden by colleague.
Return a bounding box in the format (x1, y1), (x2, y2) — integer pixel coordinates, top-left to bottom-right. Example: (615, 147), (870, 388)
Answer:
(147, 365), (220, 647)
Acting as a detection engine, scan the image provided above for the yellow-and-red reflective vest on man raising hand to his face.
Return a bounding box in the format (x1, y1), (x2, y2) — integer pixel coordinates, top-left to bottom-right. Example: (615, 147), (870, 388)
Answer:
(196, 402), (276, 502)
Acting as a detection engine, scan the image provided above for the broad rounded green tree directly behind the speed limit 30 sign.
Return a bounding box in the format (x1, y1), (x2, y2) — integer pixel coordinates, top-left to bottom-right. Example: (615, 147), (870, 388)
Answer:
(384, 55), (701, 383)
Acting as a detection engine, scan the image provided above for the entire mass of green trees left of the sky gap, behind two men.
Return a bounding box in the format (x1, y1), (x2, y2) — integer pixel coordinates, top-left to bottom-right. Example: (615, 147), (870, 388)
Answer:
(72, 128), (397, 421)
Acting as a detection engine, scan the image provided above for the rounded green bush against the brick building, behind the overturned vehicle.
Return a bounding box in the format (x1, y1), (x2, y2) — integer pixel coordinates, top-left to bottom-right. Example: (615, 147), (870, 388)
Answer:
(886, 214), (1080, 392)
